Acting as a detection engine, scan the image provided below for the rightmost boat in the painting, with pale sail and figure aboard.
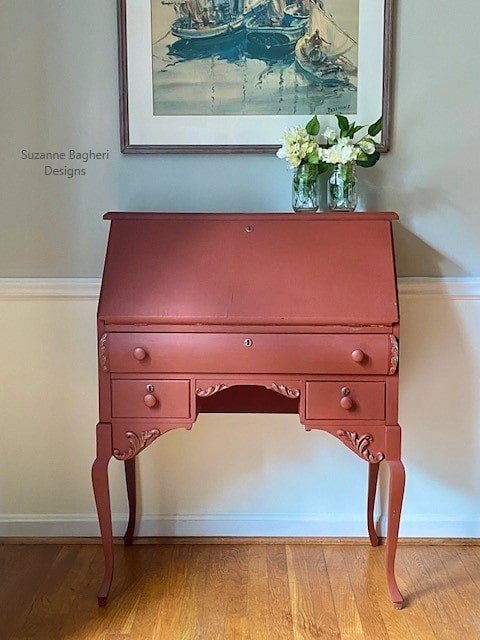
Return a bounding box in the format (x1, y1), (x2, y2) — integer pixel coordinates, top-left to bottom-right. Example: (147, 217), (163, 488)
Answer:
(295, 0), (357, 87)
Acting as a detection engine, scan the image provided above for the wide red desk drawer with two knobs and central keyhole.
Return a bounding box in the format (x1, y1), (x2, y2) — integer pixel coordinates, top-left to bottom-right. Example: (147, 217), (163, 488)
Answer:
(108, 333), (392, 375)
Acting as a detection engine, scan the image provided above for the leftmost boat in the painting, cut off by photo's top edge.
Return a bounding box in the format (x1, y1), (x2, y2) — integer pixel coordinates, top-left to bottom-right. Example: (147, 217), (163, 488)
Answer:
(172, 0), (265, 40)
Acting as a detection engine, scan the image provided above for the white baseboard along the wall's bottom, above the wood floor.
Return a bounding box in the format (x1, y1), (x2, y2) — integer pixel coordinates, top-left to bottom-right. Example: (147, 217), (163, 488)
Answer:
(0, 514), (480, 542)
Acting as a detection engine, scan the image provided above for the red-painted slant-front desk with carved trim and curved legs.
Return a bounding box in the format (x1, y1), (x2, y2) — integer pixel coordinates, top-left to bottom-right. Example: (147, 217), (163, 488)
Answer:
(92, 213), (405, 608)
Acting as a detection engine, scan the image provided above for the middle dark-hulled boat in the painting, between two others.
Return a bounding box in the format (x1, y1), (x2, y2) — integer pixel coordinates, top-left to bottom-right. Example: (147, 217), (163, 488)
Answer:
(245, 0), (308, 56)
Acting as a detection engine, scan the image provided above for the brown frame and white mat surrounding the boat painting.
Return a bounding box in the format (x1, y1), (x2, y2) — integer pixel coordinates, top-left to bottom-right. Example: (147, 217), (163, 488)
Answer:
(117, 0), (394, 154)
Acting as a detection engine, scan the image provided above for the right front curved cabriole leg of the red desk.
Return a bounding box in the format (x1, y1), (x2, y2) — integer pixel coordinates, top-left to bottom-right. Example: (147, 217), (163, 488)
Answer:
(386, 460), (405, 609)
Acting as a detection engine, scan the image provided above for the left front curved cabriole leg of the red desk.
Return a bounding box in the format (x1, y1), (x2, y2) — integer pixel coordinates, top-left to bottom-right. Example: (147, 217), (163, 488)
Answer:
(92, 423), (113, 607)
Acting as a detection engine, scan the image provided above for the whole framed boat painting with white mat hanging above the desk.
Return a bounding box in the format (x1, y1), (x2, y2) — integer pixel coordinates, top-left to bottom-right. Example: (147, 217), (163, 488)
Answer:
(118, 0), (393, 153)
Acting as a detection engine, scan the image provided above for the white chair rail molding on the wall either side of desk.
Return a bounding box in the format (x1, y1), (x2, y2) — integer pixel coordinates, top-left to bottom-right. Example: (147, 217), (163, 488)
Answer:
(0, 277), (480, 300)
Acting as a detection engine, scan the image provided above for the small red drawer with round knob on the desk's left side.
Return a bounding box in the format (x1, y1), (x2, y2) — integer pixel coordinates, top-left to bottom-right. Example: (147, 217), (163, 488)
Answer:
(112, 379), (190, 418)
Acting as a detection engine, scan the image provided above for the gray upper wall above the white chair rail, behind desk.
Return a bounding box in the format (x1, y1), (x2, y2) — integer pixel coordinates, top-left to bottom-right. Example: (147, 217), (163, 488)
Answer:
(0, 0), (480, 277)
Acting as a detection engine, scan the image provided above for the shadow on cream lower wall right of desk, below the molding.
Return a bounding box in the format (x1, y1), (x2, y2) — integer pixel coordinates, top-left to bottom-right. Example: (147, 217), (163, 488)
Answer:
(400, 296), (480, 496)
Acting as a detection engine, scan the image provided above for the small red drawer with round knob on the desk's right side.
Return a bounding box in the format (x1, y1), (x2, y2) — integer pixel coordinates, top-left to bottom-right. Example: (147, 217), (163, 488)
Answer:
(305, 380), (385, 420)
